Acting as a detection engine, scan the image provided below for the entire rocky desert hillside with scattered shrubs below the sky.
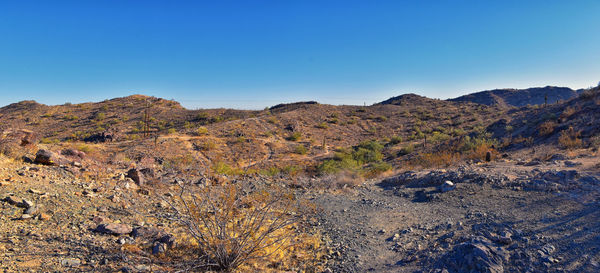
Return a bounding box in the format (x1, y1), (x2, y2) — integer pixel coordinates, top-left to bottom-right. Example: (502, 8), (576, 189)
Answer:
(0, 88), (600, 272)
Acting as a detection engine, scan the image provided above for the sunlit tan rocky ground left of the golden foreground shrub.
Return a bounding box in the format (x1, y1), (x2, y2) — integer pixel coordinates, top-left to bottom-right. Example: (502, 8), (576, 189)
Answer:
(0, 156), (185, 272)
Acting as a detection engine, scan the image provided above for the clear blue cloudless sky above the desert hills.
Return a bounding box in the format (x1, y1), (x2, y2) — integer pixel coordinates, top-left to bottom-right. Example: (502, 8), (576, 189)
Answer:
(0, 0), (600, 109)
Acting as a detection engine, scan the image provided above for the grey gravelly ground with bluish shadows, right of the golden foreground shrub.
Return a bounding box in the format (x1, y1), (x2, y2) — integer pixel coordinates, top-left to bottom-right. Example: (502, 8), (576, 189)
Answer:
(313, 153), (600, 272)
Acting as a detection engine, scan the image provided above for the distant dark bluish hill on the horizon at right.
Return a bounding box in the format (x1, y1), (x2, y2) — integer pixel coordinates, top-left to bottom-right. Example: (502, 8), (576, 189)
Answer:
(449, 86), (583, 108)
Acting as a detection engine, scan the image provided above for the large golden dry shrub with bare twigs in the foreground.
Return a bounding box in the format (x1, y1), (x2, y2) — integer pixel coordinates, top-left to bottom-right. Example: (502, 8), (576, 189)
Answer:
(164, 182), (321, 271)
